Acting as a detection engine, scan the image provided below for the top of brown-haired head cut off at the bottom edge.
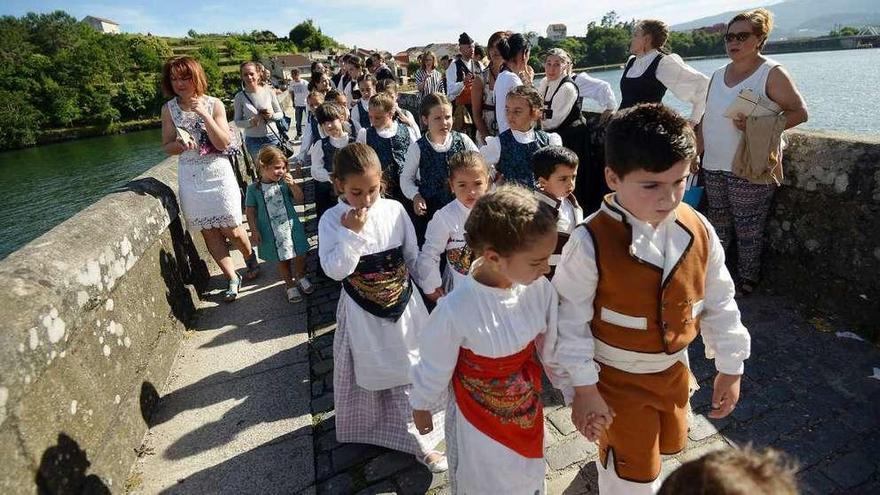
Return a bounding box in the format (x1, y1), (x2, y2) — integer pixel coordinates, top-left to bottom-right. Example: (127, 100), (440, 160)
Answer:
(657, 447), (798, 495)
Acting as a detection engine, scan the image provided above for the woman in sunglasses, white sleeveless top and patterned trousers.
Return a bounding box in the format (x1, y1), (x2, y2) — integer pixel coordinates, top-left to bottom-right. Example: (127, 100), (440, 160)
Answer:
(699, 9), (808, 294)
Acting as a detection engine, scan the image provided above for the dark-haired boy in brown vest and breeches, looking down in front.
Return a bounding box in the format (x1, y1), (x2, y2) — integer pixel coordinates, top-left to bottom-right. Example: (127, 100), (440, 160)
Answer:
(553, 104), (750, 495)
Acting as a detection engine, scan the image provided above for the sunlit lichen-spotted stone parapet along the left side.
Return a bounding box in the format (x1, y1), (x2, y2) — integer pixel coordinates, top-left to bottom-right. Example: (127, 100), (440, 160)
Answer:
(0, 158), (207, 493)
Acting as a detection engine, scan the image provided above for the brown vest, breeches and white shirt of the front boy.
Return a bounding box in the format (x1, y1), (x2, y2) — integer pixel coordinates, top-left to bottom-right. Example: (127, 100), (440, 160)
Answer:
(553, 195), (750, 495)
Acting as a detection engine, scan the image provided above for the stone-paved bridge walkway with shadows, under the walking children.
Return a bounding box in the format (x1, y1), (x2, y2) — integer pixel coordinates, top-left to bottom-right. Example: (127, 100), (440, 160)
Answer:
(127, 153), (880, 494)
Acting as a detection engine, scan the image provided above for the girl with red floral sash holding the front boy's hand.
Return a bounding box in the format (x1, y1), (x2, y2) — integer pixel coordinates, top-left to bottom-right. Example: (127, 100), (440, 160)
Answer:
(410, 186), (563, 495)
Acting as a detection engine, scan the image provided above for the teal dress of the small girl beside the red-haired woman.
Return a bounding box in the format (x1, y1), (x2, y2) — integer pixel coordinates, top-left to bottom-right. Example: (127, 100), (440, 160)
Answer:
(244, 181), (309, 261)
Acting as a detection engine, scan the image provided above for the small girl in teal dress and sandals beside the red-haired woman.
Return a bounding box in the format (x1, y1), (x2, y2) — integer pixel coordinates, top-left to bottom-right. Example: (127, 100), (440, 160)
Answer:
(244, 145), (314, 303)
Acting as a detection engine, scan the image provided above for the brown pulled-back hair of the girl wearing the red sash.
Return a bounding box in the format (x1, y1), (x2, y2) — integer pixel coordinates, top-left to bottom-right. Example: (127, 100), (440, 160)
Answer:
(464, 185), (557, 256)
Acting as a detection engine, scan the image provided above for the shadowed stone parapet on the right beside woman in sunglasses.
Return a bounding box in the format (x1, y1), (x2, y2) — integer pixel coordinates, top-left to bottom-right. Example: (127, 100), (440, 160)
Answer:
(764, 131), (880, 342)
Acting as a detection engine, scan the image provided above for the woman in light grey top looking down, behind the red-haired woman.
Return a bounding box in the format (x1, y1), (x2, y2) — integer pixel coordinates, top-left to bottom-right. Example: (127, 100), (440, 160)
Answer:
(232, 62), (284, 163)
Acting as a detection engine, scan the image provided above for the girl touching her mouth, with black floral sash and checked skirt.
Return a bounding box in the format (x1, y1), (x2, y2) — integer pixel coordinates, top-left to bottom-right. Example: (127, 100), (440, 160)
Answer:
(318, 143), (446, 472)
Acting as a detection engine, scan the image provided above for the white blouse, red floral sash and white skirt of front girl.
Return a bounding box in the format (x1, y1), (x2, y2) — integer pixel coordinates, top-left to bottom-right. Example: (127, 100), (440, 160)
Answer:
(410, 274), (562, 495)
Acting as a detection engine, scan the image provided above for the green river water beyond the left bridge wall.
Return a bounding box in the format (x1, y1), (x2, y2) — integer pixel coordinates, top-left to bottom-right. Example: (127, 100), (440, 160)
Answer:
(0, 129), (165, 259)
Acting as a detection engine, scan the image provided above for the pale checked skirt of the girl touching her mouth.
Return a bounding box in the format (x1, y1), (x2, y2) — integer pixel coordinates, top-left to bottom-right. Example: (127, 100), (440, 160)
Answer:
(333, 306), (444, 458)
